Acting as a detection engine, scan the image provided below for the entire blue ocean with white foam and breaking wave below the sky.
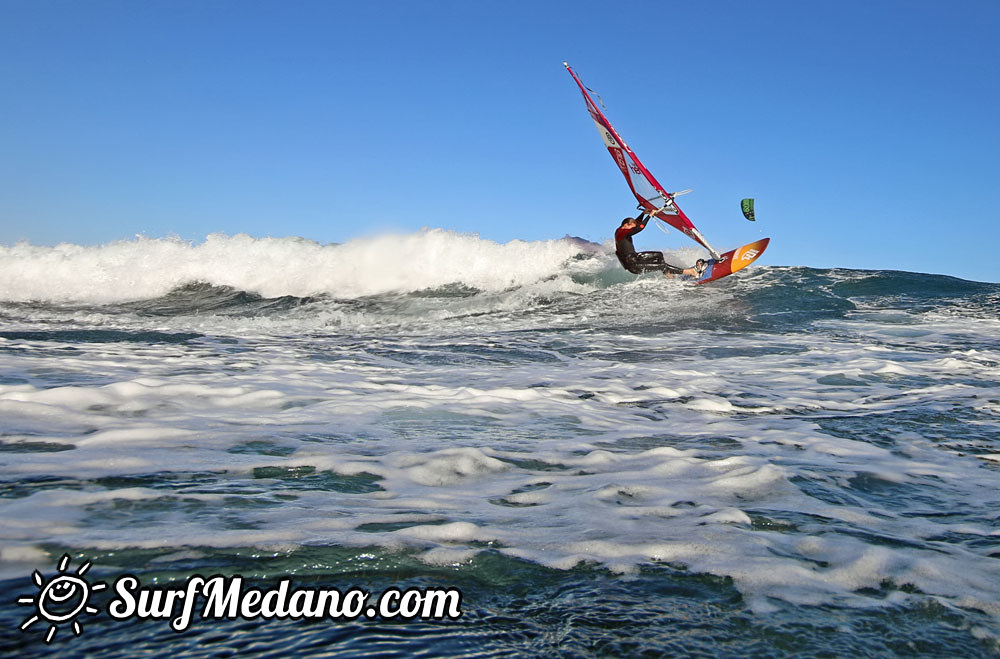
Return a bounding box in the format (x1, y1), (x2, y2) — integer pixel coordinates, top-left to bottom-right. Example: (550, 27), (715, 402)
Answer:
(0, 230), (1000, 657)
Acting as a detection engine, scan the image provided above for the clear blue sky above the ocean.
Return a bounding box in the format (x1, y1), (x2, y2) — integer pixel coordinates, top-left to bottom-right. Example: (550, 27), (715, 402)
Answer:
(0, 0), (1000, 281)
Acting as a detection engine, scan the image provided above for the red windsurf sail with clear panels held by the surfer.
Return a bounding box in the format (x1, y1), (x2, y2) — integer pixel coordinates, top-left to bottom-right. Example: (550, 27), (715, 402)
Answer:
(563, 62), (721, 259)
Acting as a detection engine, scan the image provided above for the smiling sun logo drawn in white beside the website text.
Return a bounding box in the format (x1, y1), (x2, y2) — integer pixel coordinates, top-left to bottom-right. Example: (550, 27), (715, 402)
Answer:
(17, 554), (107, 643)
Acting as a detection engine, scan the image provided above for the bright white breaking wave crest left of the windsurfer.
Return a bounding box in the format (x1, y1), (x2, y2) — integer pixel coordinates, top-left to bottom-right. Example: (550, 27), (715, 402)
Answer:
(0, 229), (613, 303)
